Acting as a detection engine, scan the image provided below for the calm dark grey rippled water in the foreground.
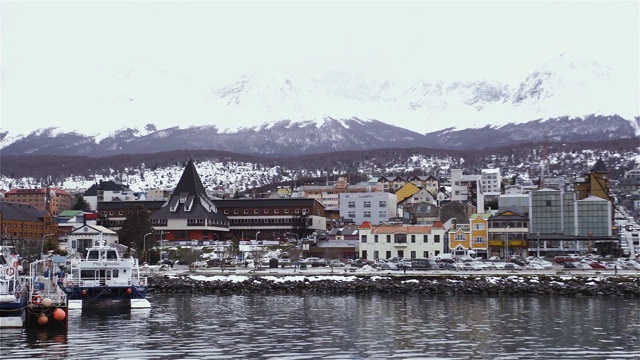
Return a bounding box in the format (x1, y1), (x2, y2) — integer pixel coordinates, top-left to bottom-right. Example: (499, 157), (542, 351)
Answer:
(0, 295), (640, 360)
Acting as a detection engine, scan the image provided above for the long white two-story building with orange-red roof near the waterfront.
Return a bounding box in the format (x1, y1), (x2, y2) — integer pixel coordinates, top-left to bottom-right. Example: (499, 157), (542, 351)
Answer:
(358, 221), (446, 261)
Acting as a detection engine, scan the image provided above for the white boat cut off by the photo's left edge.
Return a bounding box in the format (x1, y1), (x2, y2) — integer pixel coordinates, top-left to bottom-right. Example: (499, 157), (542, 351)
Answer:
(0, 246), (29, 329)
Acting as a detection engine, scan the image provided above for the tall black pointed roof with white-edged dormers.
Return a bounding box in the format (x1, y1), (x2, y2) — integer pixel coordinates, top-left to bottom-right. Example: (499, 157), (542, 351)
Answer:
(151, 159), (229, 226)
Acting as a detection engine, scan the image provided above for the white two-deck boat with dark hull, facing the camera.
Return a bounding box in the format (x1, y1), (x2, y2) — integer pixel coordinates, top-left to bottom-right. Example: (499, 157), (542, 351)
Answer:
(62, 239), (151, 309)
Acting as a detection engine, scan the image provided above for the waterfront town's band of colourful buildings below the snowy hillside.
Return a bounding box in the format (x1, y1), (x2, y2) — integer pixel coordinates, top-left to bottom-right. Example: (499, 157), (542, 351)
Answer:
(0, 160), (640, 266)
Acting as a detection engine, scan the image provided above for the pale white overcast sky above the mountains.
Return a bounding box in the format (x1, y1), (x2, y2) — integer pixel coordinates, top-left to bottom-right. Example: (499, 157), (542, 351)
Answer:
(0, 0), (640, 135)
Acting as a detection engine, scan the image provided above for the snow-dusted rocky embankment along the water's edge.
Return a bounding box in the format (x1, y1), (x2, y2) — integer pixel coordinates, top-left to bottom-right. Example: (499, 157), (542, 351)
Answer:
(149, 275), (640, 297)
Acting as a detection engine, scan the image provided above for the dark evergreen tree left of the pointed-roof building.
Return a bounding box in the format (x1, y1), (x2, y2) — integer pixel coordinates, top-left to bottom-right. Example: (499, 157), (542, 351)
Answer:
(118, 205), (155, 256)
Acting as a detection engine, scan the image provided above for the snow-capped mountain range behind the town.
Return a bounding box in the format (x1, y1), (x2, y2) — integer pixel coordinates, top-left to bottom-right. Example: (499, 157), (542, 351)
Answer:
(0, 54), (640, 156)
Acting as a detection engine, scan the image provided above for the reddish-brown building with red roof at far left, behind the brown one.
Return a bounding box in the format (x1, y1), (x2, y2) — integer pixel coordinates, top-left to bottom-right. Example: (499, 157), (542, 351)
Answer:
(4, 187), (75, 216)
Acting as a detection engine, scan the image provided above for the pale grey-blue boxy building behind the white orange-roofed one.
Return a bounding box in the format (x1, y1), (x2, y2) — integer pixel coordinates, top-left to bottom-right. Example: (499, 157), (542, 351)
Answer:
(340, 192), (398, 225)
